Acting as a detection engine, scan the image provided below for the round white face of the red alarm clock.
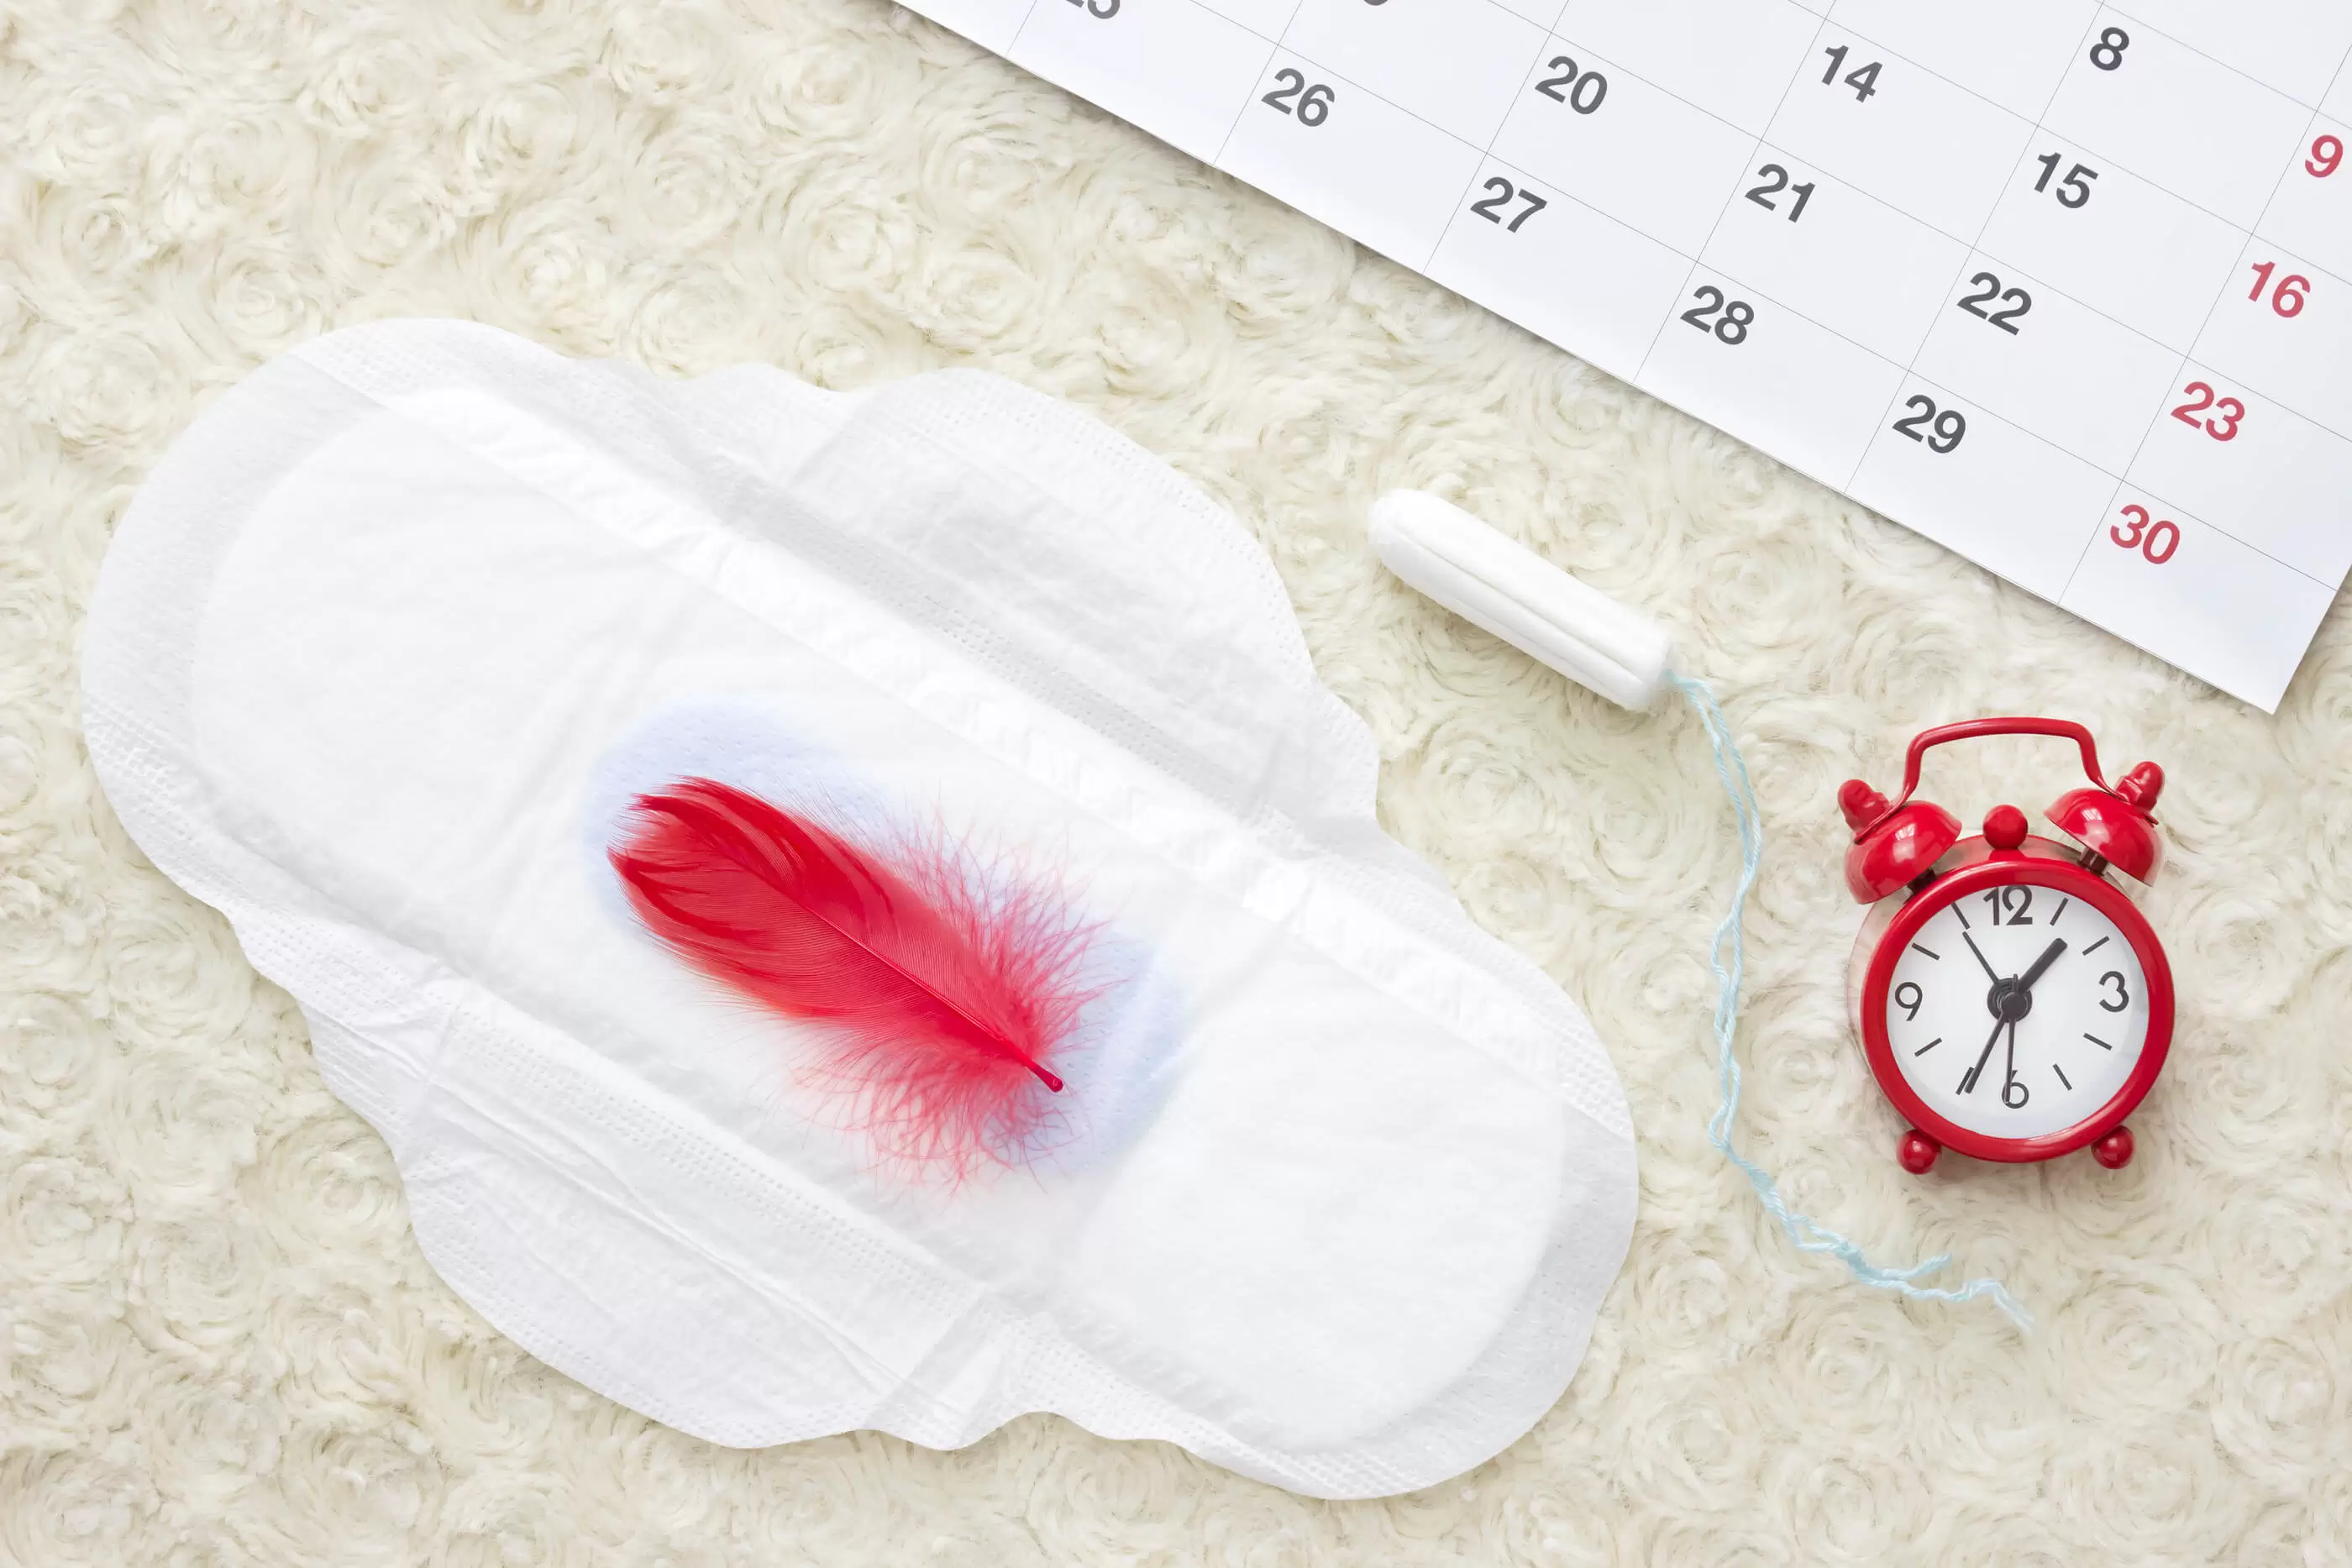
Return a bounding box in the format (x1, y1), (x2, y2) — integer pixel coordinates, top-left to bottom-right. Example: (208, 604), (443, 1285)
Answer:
(1887, 882), (2150, 1138)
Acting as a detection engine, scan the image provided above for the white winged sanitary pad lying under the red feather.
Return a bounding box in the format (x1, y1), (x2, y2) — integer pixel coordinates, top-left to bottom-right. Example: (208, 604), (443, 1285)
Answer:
(85, 322), (1635, 1497)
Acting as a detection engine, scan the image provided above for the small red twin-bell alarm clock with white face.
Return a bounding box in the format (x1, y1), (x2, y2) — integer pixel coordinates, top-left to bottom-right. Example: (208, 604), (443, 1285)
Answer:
(1837, 720), (2173, 1173)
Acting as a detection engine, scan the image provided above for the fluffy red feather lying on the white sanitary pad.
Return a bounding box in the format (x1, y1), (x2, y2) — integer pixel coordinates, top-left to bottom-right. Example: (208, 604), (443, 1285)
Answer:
(609, 779), (1099, 1171)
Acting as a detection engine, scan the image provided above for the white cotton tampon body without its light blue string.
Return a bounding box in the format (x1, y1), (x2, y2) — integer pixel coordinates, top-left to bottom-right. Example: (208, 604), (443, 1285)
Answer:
(1371, 489), (1672, 708)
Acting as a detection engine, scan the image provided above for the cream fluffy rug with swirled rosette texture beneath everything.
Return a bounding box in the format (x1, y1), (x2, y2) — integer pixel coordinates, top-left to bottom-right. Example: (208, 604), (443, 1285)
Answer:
(0, 0), (2352, 1568)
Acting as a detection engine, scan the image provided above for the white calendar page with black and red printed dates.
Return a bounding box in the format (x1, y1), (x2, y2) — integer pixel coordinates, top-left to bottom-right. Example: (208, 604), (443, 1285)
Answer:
(911, 0), (2352, 708)
